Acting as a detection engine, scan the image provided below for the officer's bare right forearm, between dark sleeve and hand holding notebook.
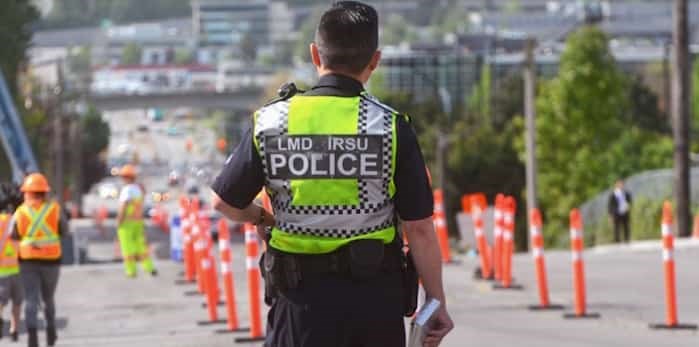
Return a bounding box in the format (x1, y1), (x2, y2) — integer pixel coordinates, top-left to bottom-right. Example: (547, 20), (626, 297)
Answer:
(402, 217), (446, 304)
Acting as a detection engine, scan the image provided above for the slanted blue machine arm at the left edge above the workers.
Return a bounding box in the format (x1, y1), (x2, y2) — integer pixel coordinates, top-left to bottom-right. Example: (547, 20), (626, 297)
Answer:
(0, 71), (39, 183)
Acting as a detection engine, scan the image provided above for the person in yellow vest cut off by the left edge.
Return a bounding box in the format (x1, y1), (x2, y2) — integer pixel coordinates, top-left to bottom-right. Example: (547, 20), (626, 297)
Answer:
(0, 185), (24, 341)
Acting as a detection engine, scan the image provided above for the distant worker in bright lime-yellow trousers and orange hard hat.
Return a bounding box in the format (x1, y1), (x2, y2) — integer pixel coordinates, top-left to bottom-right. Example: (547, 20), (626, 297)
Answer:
(117, 164), (158, 277)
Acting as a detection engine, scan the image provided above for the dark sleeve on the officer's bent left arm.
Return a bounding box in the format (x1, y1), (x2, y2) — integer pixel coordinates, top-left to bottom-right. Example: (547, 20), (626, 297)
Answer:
(211, 130), (265, 209)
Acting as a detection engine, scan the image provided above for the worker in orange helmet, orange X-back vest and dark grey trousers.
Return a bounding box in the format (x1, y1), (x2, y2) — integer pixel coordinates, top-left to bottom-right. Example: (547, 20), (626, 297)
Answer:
(12, 173), (63, 347)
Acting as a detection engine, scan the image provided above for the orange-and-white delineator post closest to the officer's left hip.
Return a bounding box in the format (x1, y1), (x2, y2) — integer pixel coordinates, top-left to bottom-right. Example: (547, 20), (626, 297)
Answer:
(235, 223), (265, 342)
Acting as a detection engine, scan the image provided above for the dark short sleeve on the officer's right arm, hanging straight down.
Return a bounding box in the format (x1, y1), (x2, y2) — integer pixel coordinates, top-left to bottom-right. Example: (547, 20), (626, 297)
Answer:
(393, 117), (433, 220)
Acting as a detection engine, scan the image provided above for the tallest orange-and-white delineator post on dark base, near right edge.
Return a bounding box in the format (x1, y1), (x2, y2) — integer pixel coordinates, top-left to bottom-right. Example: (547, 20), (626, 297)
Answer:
(650, 201), (697, 330)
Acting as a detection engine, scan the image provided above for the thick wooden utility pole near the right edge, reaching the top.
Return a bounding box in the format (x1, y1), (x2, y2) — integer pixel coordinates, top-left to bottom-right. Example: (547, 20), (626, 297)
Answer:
(672, 0), (690, 236)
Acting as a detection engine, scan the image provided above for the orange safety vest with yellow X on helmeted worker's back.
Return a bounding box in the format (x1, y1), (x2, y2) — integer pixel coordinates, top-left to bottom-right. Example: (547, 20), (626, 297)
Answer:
(15, 202), (61, 260)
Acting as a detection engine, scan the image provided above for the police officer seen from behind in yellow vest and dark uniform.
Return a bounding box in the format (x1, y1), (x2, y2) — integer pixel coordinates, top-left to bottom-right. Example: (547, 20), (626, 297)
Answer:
(212, 1), (453, 347)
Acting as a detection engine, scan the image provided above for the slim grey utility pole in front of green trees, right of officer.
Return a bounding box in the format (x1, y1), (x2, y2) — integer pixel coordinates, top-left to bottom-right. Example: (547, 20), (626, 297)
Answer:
(523, 38), (537, 239)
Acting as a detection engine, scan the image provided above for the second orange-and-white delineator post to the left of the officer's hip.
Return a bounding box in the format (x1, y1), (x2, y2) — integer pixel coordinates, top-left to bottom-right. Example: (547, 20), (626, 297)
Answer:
(216, 218), (250, 333)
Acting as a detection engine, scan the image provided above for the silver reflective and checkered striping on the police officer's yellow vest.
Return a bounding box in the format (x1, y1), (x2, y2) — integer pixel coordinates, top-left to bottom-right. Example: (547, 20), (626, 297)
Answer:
(254, 94), (398, 238)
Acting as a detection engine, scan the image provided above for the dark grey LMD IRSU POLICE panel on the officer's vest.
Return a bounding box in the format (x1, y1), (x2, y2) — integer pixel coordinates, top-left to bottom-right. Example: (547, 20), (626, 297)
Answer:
(265, 135), (383, 179)
